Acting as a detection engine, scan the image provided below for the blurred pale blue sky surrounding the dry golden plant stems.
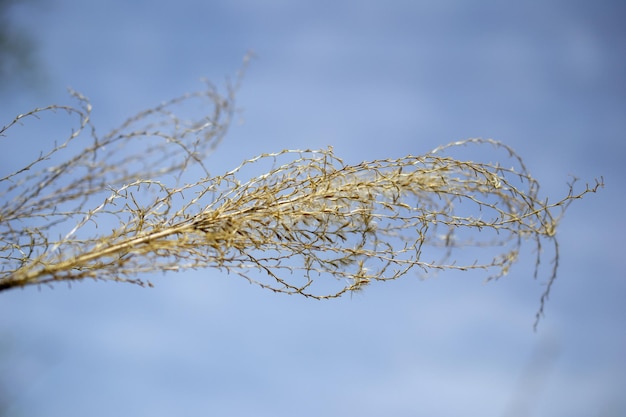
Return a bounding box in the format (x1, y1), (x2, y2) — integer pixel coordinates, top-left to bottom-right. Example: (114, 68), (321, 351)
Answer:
(0, 0), (626, 417)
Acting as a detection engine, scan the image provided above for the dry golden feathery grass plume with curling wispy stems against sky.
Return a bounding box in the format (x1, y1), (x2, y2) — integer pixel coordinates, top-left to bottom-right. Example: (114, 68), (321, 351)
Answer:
(0, 65), (602, 326)
